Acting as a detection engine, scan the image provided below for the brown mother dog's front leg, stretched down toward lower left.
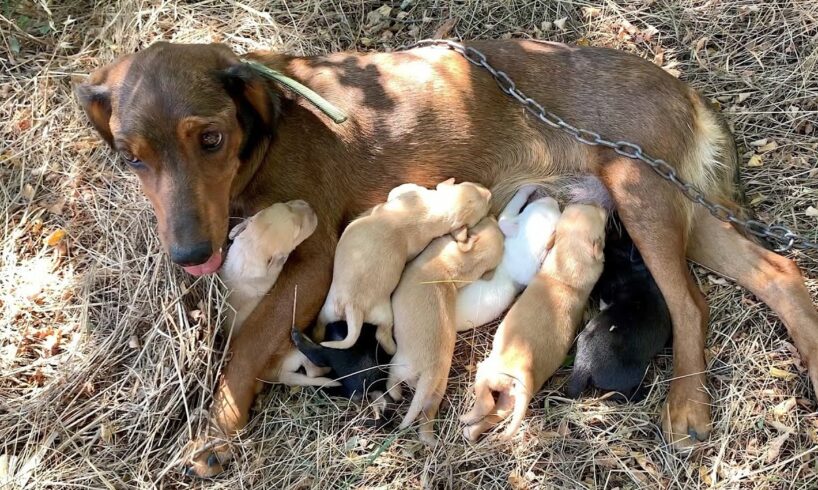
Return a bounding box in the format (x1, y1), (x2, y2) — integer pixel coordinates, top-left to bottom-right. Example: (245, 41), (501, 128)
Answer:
(186, 231), (335, 477)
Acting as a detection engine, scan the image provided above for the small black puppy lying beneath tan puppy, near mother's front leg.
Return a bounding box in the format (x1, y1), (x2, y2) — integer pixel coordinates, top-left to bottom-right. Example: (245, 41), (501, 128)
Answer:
(291, 320), (392, 426)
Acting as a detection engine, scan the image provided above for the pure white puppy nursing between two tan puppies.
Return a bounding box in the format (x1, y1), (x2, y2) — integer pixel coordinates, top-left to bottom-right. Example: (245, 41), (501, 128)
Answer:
(456, 186), (560, 332)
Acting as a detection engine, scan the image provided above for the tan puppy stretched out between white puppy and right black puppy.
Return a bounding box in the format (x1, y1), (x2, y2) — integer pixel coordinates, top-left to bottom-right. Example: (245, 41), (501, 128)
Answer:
(461, 204), (607, 440)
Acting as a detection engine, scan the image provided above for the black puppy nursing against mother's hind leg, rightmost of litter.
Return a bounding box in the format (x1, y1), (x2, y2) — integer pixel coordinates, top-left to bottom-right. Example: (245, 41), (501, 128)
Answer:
(565, 219), (672, 400)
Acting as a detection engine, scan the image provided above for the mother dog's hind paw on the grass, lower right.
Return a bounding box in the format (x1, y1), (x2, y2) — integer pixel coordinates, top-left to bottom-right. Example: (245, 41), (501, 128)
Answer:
(662, 375), (711, 450)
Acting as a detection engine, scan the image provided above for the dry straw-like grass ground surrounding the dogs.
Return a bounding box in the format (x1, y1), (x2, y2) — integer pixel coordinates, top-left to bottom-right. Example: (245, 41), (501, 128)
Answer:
(0, 0), (818, 489)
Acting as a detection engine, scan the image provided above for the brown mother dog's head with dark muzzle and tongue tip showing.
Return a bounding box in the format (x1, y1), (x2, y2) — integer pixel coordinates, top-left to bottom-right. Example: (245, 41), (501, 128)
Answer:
(75, 42), (279, 275)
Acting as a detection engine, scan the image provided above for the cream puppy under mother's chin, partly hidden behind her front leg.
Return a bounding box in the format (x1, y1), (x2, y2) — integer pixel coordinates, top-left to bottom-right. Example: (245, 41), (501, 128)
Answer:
(219, 200), (338, 386)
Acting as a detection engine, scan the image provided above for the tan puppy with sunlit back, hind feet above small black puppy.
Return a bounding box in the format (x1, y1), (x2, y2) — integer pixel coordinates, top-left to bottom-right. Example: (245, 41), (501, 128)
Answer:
(318, 179), (491, 354)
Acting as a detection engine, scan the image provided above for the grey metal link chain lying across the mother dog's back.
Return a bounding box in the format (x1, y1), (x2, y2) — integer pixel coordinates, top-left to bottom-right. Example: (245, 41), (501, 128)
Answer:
(400, 39), (818, 252)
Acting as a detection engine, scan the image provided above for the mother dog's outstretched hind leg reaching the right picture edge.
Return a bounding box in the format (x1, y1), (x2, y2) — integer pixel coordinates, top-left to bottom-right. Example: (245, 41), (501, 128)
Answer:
(687, 210), (818, 391)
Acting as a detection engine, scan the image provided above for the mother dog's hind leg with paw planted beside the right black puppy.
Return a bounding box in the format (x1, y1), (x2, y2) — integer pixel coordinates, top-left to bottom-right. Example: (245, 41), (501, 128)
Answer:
(602, 158), (710, 448)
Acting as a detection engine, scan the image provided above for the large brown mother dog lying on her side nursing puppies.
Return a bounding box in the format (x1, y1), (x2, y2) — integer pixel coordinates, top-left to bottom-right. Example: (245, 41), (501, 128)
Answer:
(77, 41), (818, 474)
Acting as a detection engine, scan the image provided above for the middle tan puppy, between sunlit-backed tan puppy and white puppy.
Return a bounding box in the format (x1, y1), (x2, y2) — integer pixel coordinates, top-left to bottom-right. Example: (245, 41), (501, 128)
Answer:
(387, 218), (503, 444)
